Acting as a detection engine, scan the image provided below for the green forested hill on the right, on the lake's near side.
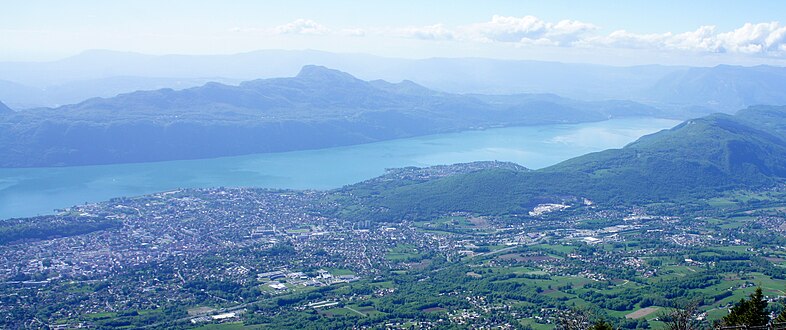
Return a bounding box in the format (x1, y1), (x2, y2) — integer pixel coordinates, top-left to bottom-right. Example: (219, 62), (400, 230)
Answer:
(344, 106), (786, 219)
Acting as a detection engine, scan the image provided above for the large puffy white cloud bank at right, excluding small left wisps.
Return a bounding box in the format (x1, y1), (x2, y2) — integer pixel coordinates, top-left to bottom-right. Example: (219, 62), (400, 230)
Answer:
(432, 15), (786, 55)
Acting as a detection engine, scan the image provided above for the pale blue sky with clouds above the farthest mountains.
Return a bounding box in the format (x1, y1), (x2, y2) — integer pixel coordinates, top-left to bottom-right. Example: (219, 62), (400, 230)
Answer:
(0, 0), (786, 65)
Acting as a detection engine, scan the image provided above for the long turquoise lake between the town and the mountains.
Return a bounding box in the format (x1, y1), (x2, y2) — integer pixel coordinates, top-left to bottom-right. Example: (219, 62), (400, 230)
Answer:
(0, 118), (679, 219)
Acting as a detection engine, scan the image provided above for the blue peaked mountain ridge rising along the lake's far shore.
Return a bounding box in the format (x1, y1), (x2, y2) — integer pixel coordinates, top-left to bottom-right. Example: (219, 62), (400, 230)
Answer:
(0, 66), (659, 167)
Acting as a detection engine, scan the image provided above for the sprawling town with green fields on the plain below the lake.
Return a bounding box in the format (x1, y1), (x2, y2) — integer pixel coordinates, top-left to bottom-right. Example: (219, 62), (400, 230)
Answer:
(0, 168), (786, 328)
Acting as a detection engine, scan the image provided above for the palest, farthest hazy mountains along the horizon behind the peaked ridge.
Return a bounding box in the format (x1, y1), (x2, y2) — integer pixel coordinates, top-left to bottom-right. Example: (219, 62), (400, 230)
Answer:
(0, 50), (786, 111)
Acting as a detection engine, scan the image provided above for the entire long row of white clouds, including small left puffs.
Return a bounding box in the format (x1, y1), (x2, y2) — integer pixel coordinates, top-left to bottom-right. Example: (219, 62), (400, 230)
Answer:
(254, 15), (786, 56)
